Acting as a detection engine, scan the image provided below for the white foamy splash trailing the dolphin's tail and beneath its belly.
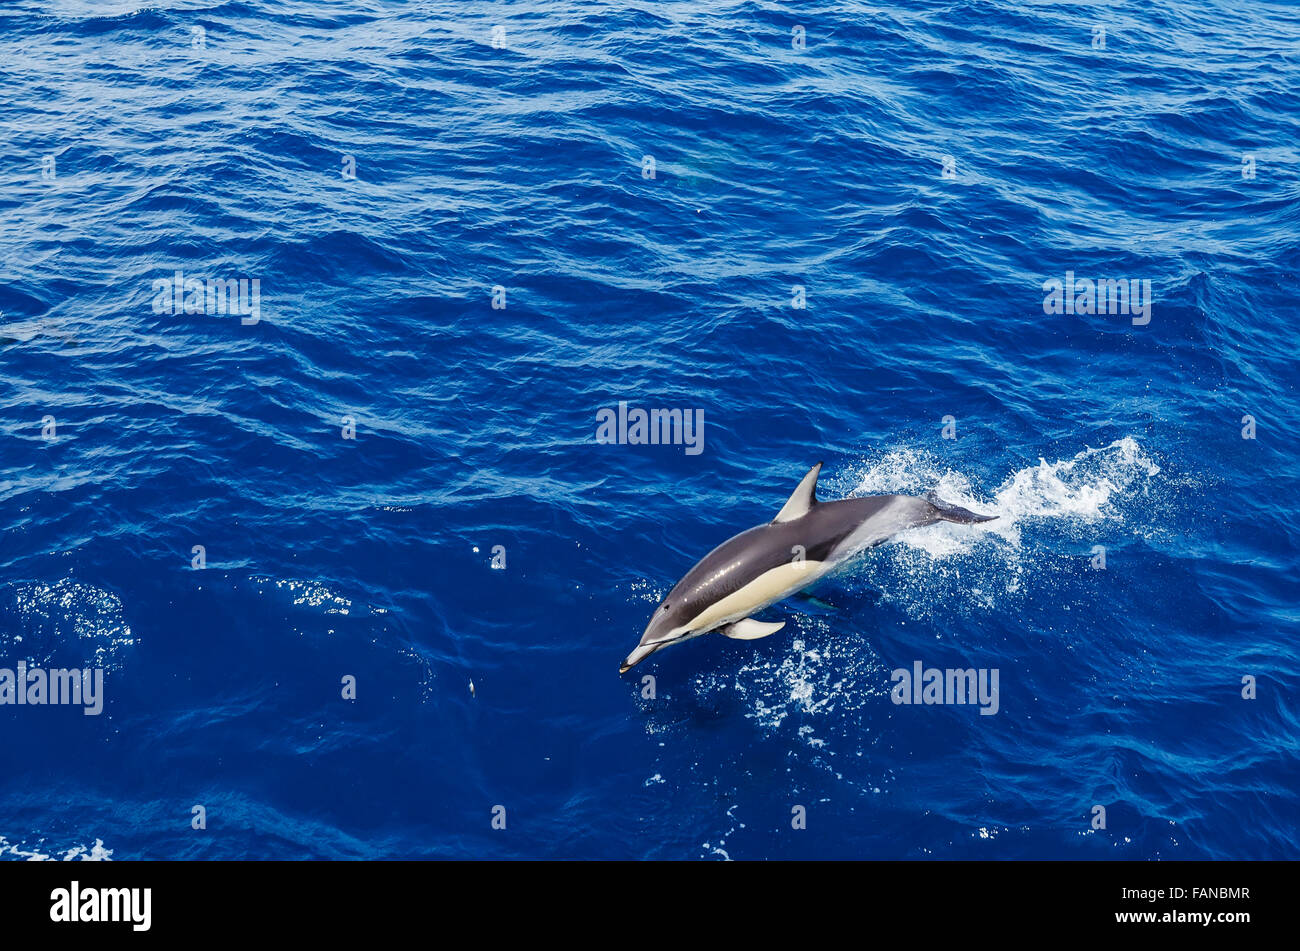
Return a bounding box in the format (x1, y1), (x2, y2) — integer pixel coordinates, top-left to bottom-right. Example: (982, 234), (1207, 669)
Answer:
(694, 437), (1161, 751)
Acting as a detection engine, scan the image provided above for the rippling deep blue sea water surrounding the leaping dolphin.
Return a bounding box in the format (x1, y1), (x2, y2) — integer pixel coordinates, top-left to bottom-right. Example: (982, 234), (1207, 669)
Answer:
(0, 0), (1300, 860)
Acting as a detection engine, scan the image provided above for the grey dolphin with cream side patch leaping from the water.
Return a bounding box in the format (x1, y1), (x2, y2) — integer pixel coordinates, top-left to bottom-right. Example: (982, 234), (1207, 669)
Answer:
(619, 463), (997, 674)
